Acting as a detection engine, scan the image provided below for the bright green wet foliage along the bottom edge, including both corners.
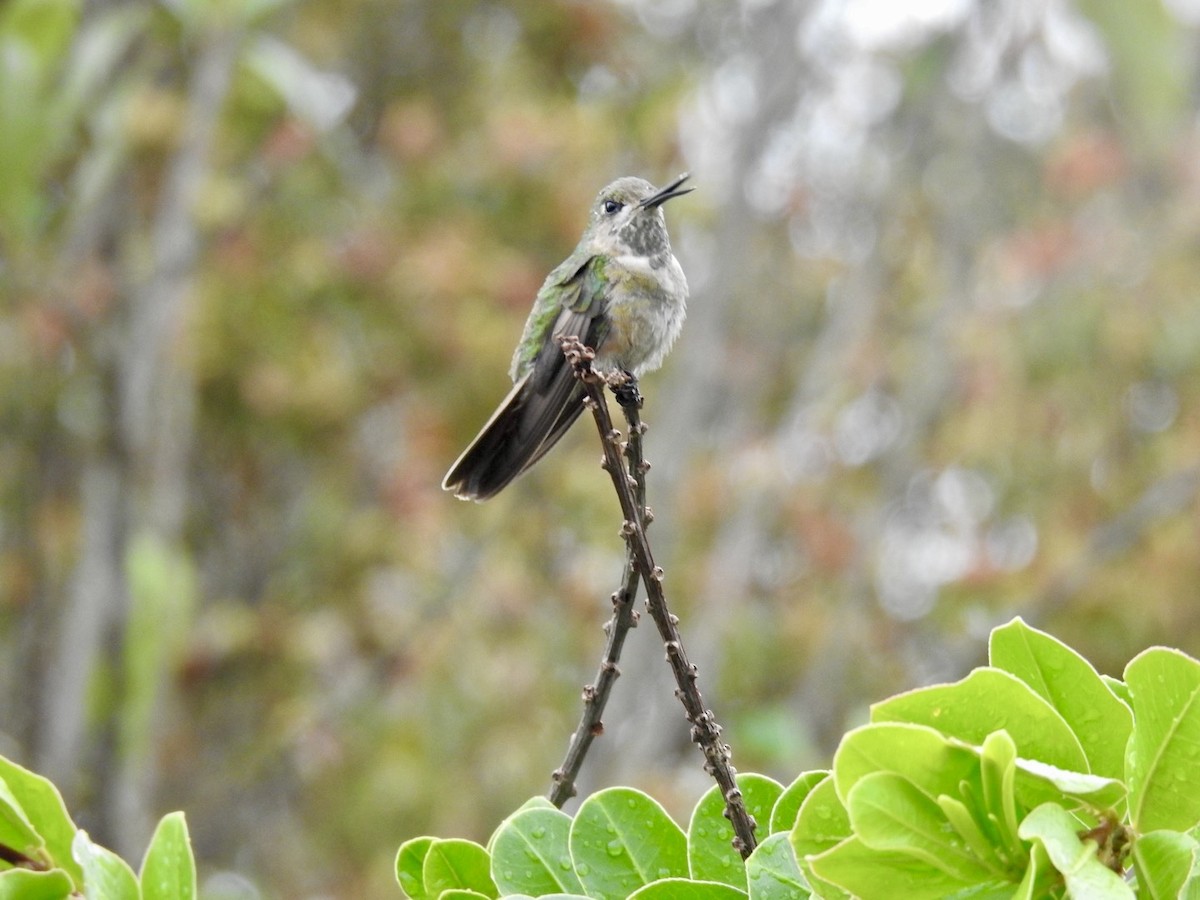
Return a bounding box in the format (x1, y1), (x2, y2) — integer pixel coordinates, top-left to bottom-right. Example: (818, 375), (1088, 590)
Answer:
(0, 619), (1200, 900)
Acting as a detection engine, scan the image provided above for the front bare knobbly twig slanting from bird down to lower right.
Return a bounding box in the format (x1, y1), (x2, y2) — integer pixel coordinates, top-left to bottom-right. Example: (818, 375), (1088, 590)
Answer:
(560, 337), (755, 858)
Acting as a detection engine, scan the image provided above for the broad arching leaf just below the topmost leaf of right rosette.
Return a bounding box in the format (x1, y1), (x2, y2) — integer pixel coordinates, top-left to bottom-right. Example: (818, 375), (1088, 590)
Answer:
(871, 668), (1087, 772)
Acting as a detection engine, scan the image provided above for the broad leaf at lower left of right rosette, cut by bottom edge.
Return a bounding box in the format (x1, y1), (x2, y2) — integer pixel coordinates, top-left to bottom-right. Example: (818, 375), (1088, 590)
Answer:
(809, 838), (988, 900)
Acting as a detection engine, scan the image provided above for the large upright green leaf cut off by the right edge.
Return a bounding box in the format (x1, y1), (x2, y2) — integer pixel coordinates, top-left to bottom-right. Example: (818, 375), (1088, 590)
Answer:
(1124, 647), (1200, 834)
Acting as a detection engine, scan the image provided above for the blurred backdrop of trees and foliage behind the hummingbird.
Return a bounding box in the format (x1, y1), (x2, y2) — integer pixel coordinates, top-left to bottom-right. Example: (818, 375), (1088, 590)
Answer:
(0, 0), (1200, 898)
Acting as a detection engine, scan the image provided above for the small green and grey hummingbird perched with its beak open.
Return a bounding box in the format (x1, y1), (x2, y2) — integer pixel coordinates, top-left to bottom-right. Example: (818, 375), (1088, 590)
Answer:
(442, 174), (695, 502)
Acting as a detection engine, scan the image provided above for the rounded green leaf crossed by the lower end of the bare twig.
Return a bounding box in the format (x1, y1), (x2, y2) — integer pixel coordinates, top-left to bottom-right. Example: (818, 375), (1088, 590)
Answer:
(688, 773), (784, 889)
